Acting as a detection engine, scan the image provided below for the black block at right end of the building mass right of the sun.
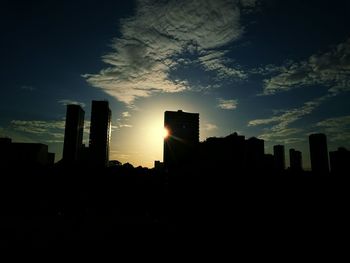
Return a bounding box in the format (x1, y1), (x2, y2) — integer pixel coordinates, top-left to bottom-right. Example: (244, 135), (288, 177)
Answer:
(245, 137), (265, 172)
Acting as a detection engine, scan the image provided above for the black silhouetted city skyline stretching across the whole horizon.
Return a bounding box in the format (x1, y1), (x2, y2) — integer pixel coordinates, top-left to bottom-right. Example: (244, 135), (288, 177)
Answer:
(0, 100), (350, 176)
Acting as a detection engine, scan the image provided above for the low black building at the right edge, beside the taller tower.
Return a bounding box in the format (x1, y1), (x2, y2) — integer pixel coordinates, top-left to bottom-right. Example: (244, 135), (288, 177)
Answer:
(329, 147), (350, 175)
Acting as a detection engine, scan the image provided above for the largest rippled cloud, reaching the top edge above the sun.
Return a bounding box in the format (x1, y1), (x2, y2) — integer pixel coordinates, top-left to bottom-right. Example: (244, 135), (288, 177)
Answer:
(83, 0), (257, 105)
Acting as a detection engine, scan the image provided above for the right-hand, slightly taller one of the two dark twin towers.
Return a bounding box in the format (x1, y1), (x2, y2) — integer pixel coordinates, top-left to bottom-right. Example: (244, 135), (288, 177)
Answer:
(89, 101), (111, 167)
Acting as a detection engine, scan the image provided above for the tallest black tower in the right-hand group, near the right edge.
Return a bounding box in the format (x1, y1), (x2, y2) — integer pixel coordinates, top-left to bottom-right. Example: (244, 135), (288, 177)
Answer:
(309, 133), (329, 174)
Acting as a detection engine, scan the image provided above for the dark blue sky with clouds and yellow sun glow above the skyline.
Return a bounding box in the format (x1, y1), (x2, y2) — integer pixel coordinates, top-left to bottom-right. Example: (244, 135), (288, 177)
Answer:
(0, 0), (350, 168)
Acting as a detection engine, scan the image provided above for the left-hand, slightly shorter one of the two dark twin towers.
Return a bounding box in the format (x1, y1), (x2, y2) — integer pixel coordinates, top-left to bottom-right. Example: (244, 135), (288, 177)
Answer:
(63, 105), (85, 163)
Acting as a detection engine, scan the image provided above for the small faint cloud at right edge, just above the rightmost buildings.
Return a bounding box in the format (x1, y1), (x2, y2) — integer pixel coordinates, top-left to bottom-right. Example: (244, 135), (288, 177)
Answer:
(315, 115), (350, 143)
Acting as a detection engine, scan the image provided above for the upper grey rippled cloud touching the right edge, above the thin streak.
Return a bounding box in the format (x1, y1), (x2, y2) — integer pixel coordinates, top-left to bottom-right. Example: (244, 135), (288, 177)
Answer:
(262, 38), (350, 95)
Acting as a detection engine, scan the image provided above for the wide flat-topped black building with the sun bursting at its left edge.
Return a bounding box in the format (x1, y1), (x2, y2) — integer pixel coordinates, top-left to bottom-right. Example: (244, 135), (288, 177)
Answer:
(163, 110), (199, 171)
